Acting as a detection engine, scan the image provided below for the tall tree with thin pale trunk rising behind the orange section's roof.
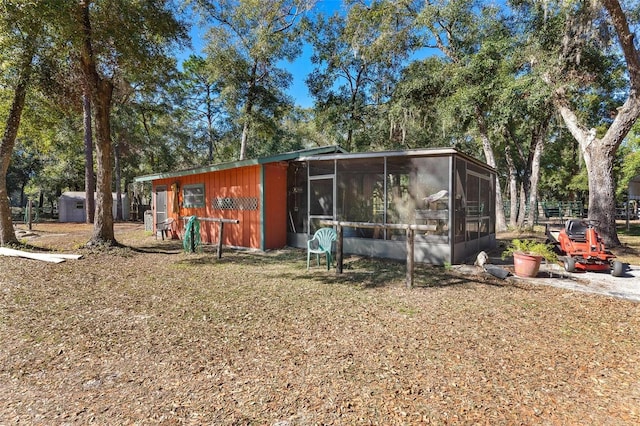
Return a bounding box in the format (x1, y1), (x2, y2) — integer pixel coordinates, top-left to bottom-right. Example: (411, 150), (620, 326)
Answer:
(192, 0), (309, 158)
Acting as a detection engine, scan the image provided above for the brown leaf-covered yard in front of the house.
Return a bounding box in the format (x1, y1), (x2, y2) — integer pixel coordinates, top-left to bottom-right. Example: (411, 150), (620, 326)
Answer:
(0, 224), (640, 426)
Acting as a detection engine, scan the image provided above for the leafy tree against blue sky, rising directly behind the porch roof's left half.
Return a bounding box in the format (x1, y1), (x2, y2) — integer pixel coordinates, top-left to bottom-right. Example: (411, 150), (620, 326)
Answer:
(306, 1), (419, 151)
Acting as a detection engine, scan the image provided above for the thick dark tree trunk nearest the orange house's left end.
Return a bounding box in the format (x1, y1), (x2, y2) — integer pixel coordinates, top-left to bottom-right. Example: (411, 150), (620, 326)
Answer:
(78, 0), (116, 245)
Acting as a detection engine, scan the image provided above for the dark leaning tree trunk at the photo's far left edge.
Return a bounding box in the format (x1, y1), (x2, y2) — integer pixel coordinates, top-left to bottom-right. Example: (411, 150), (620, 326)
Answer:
(0, 46), (35, 246)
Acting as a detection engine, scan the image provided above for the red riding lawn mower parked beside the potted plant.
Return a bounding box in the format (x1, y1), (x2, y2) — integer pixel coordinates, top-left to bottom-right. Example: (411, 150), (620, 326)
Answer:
(547, 219), (624, 277)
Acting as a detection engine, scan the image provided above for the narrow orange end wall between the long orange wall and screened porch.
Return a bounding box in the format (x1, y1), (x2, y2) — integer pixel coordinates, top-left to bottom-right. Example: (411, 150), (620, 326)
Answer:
(264, 163), (287, 249)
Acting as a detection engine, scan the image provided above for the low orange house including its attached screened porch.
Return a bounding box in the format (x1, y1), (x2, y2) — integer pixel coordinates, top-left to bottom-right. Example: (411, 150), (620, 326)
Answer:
(134, 146), (496, 264)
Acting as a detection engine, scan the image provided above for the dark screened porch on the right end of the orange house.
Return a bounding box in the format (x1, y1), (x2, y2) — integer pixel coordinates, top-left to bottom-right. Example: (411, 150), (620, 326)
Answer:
(287, 148), (495, 265)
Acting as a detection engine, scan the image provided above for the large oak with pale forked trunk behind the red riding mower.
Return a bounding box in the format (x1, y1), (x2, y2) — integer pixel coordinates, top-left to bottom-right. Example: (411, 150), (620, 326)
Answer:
(518, 0), (640, 246)
